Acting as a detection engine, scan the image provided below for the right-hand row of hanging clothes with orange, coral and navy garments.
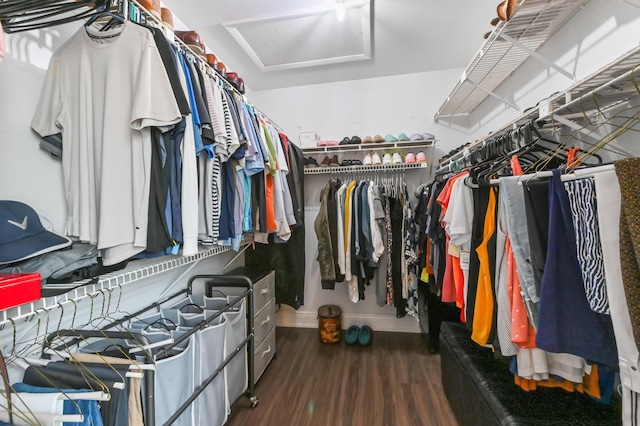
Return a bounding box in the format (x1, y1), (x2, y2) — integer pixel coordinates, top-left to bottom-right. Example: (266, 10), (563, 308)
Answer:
(417, 95), (640, 416)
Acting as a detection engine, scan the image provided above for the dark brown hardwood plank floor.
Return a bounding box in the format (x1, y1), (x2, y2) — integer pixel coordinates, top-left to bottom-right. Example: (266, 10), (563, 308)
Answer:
(227, 328), (457, 426)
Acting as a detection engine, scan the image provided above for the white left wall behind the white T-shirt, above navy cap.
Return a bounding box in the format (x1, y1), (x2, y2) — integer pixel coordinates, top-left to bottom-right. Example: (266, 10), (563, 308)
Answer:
(0, 23), (79, 233)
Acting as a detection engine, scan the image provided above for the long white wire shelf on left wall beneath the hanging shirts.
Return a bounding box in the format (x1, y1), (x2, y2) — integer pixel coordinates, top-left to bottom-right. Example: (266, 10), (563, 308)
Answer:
(0, 242), (246, 322)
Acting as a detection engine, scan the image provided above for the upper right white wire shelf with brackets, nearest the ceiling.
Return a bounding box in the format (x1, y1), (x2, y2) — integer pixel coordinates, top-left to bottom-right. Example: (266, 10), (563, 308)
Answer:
(434, 0), (589, 121)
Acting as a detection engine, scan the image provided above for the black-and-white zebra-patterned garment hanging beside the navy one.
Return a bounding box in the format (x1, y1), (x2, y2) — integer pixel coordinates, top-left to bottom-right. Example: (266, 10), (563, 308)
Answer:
(564, 178), (609, 315)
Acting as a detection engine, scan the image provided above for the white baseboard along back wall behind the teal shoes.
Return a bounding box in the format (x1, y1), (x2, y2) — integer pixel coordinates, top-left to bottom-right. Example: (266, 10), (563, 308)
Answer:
(276, 310), (420, 333)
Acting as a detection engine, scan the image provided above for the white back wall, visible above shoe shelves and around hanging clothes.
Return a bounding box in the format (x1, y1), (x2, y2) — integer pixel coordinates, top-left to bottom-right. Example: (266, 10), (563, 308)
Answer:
(251, 69), (468, 332)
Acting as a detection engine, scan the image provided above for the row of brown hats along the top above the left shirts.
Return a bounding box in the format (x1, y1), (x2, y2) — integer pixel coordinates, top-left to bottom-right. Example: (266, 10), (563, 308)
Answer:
(140, 0), (245, 94)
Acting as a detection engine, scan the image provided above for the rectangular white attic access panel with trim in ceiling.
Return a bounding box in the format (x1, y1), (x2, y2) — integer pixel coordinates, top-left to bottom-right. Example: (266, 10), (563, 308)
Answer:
(223, 0), (372, 71)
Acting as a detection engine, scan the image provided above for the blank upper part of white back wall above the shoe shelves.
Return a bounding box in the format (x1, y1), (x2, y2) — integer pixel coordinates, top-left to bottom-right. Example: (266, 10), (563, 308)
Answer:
(251, 65), (466, 156)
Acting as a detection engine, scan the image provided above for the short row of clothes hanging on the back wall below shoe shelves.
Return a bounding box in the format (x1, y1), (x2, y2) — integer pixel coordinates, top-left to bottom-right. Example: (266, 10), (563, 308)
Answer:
(314, 172), (417, 318)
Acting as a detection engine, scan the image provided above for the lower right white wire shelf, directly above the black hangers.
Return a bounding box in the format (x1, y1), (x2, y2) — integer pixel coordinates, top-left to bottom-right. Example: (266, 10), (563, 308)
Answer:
(437, 47), (640, 173)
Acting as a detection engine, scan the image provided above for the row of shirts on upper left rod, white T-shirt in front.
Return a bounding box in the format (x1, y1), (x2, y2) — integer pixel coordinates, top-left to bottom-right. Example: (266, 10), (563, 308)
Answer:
(24, 2), (302, 276)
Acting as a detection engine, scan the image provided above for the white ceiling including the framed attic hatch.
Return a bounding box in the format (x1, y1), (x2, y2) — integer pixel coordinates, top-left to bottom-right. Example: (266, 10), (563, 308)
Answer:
(163, 0), (499, 90)
